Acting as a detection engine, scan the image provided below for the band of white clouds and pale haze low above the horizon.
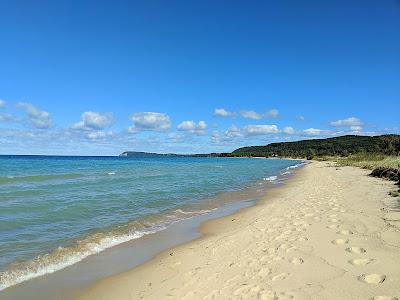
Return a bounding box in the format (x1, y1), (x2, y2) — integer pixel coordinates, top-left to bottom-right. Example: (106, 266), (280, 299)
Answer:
(0, 100), (399, 155)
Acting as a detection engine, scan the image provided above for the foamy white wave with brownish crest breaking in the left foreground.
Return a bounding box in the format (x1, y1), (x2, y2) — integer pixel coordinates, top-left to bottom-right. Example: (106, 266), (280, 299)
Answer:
(0, 208), (215, 291)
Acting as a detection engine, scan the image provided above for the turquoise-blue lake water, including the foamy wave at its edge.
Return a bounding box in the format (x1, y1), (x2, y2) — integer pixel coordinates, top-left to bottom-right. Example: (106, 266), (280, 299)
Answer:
(0, 156), (299, 289)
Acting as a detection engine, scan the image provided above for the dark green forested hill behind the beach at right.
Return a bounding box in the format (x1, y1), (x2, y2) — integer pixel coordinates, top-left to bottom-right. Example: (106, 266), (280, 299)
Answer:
(231, 134), (400, 157)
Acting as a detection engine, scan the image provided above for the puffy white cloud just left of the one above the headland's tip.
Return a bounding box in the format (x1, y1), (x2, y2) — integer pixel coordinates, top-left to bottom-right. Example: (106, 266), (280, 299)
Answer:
(71, 111), (115, 130)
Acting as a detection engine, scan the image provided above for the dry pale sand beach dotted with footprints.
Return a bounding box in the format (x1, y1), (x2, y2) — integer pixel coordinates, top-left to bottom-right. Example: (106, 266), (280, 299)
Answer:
(82, 162), (400, 299)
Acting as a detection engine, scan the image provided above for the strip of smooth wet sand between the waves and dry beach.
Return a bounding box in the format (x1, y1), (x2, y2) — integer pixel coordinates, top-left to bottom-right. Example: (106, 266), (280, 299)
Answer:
(0, 160), (304, 299)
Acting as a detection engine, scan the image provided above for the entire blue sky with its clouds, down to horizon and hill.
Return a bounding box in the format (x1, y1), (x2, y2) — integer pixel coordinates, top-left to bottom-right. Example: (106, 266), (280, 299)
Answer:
(0, 0), (400, 155)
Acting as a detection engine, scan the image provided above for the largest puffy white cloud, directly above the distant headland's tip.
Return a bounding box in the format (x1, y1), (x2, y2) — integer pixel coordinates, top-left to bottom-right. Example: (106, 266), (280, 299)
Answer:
(128, 112), (171, 132)
